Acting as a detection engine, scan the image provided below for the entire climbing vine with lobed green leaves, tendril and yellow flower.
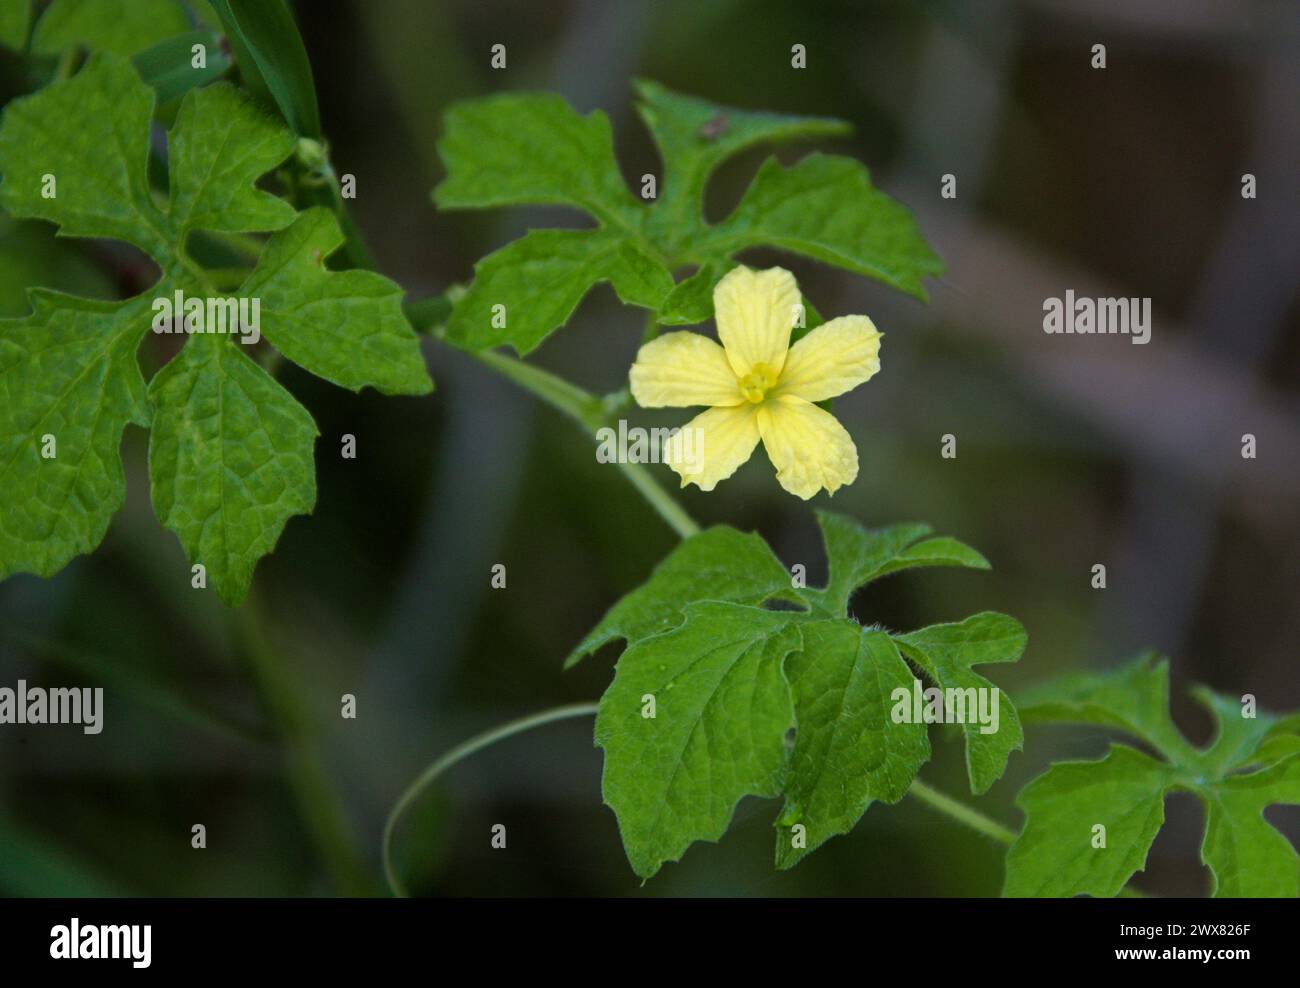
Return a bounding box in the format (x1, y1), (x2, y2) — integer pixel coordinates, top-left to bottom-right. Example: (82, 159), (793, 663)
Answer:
(0, 0), (1300, 896)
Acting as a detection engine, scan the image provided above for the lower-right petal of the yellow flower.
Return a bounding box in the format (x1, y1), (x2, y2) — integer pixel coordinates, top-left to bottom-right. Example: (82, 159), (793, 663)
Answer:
(758, 395), (858, 501)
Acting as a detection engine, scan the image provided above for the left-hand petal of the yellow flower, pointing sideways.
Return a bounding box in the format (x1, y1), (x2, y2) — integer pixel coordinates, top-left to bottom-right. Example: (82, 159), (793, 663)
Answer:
(628, 333), (745, 408)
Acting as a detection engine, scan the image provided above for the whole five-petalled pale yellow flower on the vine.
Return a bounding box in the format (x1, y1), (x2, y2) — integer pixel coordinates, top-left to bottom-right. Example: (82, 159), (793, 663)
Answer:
(629, 267), (881, 501)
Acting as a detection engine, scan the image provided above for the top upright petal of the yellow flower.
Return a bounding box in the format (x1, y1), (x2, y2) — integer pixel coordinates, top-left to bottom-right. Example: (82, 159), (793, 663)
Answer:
(714, 265), (802, 377)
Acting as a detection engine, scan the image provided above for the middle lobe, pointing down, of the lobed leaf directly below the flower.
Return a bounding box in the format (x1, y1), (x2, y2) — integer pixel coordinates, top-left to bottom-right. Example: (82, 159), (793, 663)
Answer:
(776, 619), (930, 868)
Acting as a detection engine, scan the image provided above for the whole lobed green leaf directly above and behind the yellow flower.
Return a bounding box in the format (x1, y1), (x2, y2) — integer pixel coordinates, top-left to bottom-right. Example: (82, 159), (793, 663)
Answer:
(434, 81), (941, 354)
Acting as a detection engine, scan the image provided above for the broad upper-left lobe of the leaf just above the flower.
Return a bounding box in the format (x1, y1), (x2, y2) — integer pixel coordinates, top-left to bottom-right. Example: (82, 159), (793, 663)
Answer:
(433, 92), (644, 230)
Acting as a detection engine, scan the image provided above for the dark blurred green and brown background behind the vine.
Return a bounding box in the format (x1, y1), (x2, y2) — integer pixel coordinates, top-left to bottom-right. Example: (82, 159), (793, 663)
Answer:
(0, 0), (1300, 896)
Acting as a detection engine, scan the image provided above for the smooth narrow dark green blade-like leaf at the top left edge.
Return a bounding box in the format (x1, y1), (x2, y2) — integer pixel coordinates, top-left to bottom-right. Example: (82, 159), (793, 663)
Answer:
(212, 0), (321, 138)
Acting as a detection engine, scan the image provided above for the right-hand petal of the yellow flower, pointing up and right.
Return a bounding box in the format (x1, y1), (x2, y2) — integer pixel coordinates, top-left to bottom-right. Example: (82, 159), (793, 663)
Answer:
(770, 316), (881, 402)
